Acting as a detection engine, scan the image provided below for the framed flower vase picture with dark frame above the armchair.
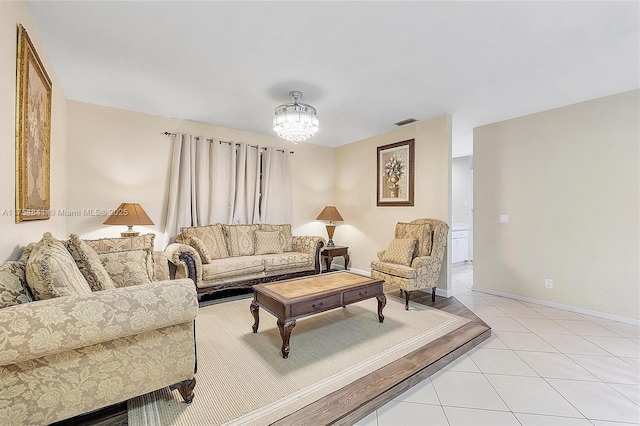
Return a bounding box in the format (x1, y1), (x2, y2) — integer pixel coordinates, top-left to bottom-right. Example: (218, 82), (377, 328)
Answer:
(377, 139), (415, 207)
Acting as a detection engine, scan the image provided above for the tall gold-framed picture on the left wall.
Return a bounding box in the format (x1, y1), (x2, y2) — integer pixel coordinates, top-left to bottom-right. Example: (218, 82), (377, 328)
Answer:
(15, 24), (52, 223)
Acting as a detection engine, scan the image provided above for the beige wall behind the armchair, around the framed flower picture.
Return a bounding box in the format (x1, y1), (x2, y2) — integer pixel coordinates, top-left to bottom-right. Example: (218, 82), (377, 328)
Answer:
(333, 115), (451, 289)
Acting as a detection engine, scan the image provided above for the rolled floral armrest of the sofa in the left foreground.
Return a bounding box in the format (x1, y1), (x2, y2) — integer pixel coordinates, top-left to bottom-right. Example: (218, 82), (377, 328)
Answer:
(0, 279), (198, 366)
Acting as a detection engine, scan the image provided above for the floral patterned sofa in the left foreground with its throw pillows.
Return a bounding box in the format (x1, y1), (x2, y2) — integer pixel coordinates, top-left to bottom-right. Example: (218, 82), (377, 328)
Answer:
(0, 233), (198, 425)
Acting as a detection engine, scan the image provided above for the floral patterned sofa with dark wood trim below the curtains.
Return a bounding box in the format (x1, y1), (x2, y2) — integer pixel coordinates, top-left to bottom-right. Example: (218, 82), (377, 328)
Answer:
(165, 224), (325, 297)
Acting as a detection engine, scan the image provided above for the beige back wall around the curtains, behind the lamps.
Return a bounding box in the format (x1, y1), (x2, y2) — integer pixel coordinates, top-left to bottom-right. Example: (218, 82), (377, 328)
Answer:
(68, 101), (334, 249)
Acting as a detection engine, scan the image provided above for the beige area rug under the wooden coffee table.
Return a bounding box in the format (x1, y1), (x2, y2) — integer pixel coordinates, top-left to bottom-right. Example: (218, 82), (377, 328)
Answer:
(128, 297), (468, 426)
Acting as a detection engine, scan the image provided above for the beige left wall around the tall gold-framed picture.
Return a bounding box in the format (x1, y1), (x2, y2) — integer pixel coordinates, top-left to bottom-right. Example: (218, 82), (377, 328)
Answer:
(0, 1), (68, 262)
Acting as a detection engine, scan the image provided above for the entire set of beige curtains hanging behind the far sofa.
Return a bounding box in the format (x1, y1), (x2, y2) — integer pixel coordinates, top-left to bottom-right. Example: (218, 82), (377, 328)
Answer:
(163, 133), (293, 247)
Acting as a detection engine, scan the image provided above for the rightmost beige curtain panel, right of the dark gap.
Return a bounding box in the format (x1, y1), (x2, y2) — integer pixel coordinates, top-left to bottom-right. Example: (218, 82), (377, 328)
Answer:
(260, 147), (293, 224)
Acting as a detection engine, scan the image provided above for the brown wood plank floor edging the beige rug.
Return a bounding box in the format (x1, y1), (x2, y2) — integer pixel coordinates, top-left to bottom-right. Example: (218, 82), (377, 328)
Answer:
(54, 290), (491, 426)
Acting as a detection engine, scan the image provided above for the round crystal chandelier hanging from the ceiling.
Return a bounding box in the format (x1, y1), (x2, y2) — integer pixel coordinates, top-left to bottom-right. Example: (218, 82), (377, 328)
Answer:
(273, 90), (318, 144)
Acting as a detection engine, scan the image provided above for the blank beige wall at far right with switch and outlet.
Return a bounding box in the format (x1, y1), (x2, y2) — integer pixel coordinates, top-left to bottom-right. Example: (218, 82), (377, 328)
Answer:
(474, 90), (640, 320)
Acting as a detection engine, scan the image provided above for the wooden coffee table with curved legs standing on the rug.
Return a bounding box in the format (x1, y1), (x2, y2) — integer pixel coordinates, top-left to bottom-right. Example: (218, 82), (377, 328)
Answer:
(251, 272), (387, 358)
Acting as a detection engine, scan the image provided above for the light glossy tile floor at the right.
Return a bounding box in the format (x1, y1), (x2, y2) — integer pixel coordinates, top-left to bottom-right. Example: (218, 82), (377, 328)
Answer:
(358, 265), (640, 426)
